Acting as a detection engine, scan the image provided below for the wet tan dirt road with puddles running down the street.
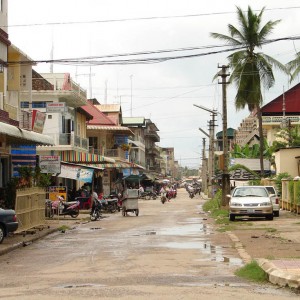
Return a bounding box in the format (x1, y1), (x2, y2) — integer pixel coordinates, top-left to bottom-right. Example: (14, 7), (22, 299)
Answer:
(0, 190), (298, 300)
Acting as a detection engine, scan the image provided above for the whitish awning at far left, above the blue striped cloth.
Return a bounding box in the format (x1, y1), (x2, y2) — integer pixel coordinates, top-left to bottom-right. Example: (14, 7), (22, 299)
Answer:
(0, 122), (54, 145)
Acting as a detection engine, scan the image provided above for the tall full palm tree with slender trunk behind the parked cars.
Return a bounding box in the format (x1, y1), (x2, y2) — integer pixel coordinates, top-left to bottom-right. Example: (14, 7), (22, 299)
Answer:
(211, 6), (286, 175)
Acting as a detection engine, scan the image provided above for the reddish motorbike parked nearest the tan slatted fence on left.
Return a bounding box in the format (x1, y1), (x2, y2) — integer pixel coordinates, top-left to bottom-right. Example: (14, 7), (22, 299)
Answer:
(47, 198), (80, 218)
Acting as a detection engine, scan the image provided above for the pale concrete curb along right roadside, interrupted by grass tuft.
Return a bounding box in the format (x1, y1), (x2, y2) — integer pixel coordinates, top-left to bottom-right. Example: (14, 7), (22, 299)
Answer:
(226, 231), (300, 289)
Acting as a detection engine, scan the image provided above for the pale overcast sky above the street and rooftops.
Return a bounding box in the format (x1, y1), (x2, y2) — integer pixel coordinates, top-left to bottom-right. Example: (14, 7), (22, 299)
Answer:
(8, 0), (300, 168)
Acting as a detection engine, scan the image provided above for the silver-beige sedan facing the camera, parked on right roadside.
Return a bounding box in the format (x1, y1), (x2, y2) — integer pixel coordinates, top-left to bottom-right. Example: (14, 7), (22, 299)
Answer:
(228, 186), (273, 221)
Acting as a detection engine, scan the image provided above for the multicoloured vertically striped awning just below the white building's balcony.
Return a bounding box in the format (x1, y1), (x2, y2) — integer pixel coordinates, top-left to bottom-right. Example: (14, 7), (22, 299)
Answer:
(60, 151), (115, 164)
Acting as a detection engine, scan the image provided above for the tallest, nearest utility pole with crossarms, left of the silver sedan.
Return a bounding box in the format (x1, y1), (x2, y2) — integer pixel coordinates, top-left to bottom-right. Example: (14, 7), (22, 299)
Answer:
(218, 65), (230, 206)
